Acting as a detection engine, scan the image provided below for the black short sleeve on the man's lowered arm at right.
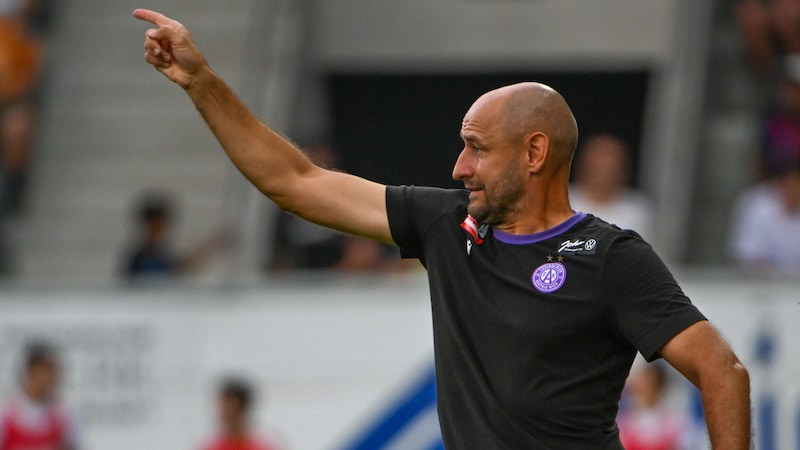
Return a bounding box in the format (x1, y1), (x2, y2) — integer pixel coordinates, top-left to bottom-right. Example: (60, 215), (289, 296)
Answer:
(602, 232), (705, 361)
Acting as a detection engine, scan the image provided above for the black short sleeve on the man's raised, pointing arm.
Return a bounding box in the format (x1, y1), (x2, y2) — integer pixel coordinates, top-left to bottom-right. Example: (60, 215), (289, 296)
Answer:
(386, 186), (468, 264)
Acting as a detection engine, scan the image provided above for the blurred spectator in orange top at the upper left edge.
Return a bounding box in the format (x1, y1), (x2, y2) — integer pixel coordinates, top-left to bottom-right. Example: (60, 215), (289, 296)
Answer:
(0, 0), (43, 212)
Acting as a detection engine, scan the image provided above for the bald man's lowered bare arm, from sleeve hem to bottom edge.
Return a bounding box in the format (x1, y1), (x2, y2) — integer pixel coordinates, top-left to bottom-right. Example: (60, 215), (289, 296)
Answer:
(661, 321), (751, 450)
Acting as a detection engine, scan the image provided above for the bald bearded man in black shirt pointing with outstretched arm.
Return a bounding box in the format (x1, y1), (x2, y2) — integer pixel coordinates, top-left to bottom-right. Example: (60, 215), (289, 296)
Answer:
(134, 10), (750, 450)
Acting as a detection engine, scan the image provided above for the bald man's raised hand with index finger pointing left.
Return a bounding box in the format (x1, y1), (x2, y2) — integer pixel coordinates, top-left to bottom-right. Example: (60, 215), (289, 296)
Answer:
(133, 9), (208, 89)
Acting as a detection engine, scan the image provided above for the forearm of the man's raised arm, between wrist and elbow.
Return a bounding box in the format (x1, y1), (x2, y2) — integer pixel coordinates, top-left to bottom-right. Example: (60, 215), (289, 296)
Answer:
(186, 67), (314, 203)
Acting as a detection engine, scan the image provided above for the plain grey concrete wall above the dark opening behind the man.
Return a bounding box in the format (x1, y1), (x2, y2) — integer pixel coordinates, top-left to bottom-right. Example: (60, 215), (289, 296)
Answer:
(312, 0), (678, 70)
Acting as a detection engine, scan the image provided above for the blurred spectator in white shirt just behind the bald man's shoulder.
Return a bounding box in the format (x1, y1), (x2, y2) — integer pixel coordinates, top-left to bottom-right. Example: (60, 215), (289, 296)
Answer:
(570, 134), (653, 239)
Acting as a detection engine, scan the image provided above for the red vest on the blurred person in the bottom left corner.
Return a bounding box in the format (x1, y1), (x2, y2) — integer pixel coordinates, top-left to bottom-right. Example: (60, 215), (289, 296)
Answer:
(0, 405), (67, 450)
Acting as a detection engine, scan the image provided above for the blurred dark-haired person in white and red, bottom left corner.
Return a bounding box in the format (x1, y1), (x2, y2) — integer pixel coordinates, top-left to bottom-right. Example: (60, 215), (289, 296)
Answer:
(0, 343), (79, 450)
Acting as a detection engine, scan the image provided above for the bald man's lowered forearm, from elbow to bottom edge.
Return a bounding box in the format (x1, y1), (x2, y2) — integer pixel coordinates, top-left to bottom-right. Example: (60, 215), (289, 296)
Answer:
(698, 362), (751, 450)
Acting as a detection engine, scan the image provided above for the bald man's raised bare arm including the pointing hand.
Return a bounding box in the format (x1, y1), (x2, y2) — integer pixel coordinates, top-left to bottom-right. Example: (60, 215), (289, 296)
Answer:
(134, 9), (392, 242)
